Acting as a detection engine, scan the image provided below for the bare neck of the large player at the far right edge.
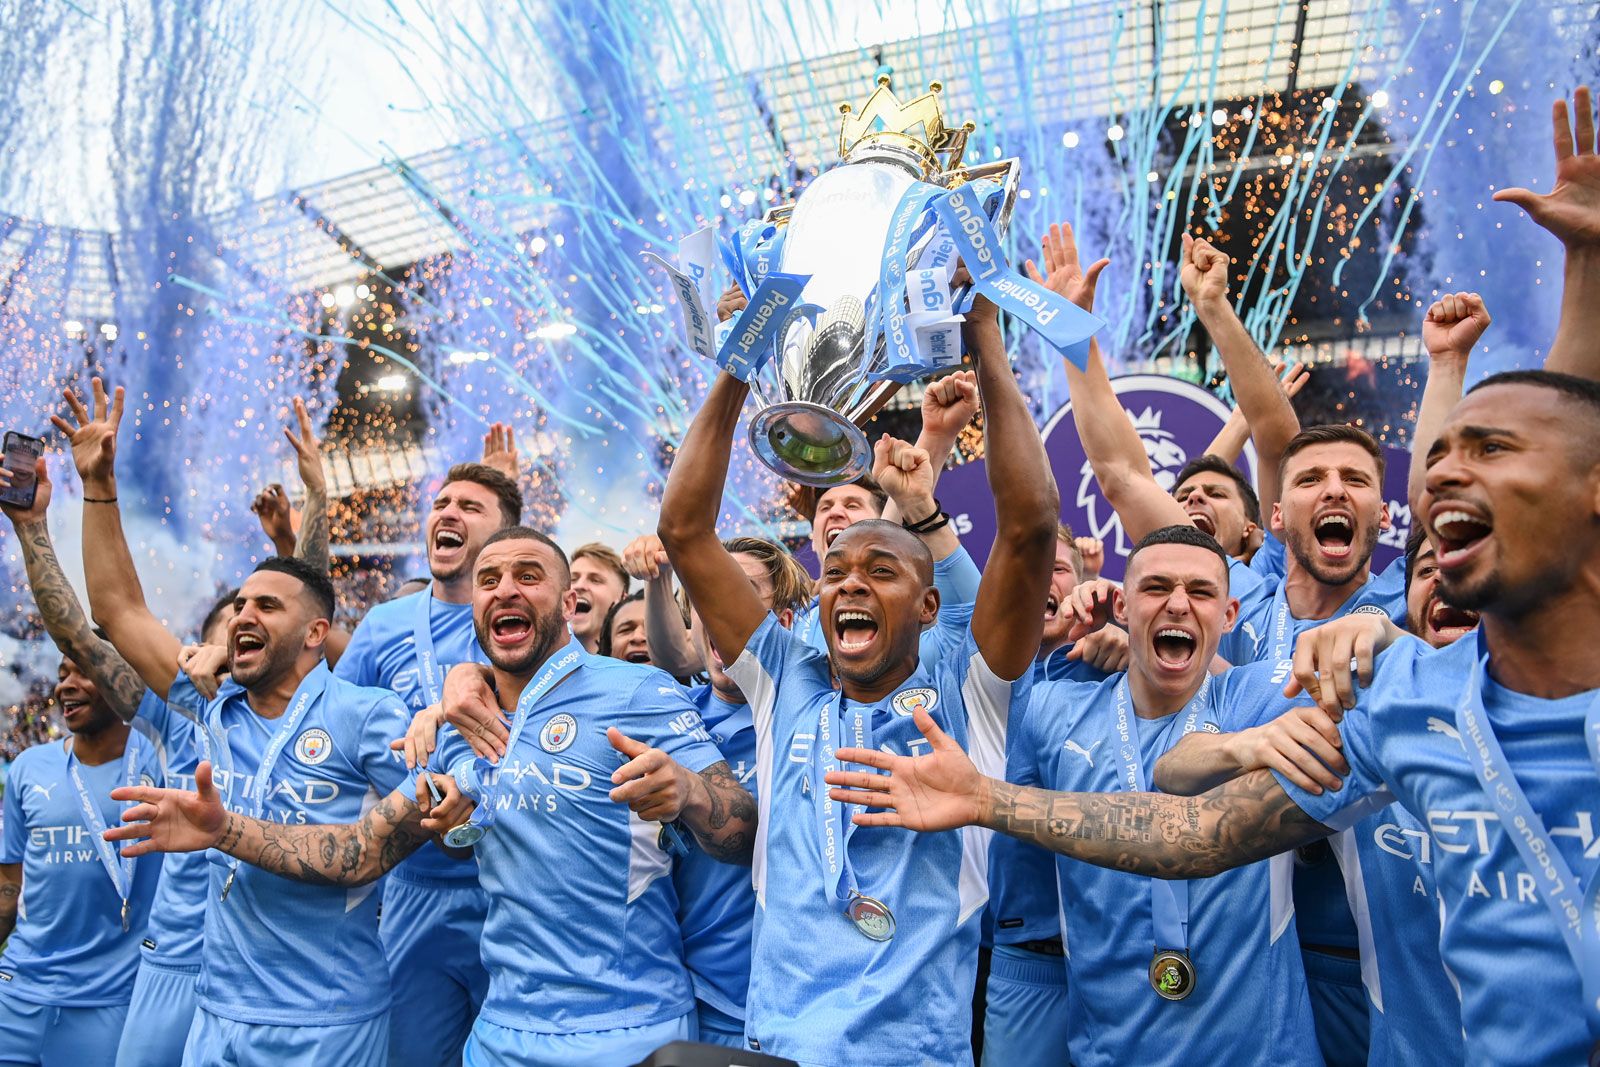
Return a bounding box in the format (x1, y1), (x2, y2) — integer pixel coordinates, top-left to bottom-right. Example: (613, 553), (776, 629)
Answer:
(1461, 568), (1600, 701)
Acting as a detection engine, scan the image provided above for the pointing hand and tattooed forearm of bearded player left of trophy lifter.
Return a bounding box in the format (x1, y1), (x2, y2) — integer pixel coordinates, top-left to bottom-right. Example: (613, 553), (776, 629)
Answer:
(606, 726), (757, 865)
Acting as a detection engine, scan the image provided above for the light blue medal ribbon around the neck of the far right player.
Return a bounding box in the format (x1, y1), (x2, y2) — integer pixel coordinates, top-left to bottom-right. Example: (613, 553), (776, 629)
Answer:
(1456, 630), (1600, 1041)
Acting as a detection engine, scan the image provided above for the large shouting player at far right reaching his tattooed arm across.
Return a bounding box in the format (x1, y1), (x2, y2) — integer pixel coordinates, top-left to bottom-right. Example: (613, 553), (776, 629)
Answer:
(834, 367), (1600, 1065)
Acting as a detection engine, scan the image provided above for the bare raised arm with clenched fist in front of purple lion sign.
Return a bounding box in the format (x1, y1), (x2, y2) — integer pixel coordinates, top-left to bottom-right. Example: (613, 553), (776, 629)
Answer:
(1181, 234), (1299, 514)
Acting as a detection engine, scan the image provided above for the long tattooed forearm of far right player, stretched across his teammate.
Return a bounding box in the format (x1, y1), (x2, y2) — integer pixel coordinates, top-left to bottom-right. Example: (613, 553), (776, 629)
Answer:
(984, 771), (1331, 878)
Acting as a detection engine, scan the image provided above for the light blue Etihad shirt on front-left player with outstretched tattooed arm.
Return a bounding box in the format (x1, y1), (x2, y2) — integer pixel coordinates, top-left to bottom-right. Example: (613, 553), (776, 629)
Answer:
(195, 664), (411, 1025)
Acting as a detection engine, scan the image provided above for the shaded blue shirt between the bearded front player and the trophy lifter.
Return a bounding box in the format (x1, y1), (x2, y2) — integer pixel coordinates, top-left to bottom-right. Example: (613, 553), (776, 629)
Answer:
(672, 685), (760, 1019)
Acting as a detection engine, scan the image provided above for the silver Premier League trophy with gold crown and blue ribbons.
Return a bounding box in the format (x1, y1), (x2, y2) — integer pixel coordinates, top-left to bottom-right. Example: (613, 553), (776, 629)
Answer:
(646, 75), (1101, 486)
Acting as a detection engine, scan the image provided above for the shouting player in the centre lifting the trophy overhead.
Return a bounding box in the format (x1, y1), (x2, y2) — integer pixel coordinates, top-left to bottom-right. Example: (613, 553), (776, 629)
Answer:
(658, 289), (1059, 1067)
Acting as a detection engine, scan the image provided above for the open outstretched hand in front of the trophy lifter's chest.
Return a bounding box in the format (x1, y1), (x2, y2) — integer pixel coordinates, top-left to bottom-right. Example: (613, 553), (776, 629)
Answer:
(822, 709), (989, 832)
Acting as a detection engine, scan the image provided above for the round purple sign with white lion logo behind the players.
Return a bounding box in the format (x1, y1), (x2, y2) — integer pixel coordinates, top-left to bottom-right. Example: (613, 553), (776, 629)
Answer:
(939, 374), (1256, 581)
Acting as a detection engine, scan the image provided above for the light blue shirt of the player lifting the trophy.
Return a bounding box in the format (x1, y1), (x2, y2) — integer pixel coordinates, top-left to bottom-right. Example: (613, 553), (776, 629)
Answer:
(728, 608), (1030, 1067)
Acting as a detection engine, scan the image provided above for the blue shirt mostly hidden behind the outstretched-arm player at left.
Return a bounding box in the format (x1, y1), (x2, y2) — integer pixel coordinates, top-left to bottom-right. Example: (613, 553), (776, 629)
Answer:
(133, 675), (211, 968)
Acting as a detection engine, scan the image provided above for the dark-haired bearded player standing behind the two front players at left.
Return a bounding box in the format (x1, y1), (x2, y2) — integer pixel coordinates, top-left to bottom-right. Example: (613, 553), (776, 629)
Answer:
(333, 462), (522, 1065)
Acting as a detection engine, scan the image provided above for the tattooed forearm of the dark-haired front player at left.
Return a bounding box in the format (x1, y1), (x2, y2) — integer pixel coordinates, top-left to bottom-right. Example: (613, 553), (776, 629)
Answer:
(216, 790), (429, 886)
